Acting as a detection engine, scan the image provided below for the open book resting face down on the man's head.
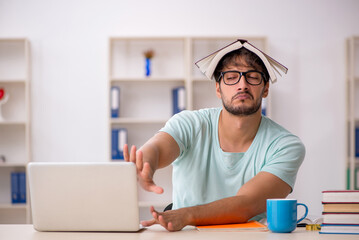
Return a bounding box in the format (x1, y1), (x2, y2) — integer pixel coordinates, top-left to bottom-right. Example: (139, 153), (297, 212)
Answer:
(195, 39), (288, 83)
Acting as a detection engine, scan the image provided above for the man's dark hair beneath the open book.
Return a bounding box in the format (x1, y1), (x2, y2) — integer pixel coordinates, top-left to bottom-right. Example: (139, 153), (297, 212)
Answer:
(213, 47), (269, 83)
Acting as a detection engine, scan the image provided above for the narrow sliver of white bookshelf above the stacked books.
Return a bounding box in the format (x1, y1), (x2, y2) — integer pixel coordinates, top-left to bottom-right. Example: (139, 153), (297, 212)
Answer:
(346, 36), (359, 190)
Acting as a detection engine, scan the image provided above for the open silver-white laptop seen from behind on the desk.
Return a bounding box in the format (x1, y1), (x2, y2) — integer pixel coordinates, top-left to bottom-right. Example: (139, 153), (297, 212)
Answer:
(27, 162), (140, 232)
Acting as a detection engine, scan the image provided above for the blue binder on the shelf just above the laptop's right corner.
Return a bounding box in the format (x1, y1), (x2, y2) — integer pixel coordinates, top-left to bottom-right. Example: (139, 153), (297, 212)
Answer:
(111, 128), (127, 160)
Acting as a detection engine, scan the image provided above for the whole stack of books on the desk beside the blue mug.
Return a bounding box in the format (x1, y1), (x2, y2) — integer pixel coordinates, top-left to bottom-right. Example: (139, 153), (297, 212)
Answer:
(319, 190), (359, 234)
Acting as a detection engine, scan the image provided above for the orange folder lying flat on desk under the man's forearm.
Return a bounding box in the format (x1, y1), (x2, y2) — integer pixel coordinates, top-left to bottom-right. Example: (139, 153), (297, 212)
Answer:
(196, 221), (268, 232)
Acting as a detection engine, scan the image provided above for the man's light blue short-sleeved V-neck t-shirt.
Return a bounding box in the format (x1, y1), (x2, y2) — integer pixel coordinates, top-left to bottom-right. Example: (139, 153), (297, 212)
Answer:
(160, 108), (305, 220)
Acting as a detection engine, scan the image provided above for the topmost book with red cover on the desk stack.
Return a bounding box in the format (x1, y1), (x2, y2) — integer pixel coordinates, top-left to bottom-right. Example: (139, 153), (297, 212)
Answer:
(322, 190), (359, 204)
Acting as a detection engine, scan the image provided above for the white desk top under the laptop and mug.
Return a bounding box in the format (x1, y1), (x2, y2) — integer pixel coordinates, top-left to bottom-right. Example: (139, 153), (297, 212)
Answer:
(0, 225), (359, 240)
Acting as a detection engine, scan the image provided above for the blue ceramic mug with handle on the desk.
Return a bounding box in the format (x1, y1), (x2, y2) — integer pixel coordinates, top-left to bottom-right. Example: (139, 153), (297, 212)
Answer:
(267, 198), (308, 233)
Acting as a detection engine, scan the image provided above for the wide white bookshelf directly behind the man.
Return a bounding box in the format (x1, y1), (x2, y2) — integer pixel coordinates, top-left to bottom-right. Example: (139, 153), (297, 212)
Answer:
(108, 37), (270, 219)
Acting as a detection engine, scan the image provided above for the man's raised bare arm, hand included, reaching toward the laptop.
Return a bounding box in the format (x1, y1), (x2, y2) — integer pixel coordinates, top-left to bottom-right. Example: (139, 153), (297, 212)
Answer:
(124, 132), (180, 193)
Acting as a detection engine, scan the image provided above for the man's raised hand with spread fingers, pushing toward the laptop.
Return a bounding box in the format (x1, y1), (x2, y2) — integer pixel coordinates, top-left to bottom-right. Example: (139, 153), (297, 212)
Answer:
(123, 144), (163, 194)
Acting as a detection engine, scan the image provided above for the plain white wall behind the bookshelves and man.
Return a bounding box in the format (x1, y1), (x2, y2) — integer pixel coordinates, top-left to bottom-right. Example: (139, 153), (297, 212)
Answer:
(0, 0), (359, 218)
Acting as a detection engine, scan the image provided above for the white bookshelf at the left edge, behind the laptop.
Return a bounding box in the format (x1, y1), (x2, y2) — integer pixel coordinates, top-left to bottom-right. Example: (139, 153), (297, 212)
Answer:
(0, 38), (31, 223)
